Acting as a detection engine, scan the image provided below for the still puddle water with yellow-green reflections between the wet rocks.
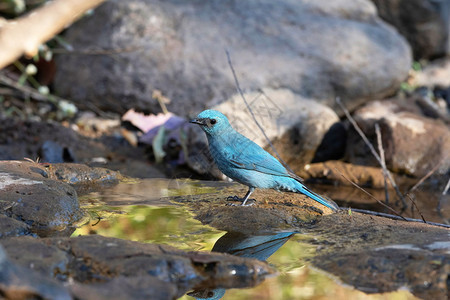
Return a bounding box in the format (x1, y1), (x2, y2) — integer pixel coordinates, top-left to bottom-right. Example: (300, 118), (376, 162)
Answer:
(73, 180), (416, 300)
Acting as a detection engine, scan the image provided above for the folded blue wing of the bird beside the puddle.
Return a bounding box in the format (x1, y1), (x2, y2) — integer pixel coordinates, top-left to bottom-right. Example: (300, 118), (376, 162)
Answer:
(229, 144), (303, 182)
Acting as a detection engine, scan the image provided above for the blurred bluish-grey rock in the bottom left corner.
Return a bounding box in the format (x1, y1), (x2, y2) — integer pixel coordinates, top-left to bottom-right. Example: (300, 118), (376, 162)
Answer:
(0, 246), (72, 300)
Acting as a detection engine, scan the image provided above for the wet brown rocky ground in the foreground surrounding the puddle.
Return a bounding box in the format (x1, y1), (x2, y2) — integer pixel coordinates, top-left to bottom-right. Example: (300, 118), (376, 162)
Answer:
(0, 161), (450, 299)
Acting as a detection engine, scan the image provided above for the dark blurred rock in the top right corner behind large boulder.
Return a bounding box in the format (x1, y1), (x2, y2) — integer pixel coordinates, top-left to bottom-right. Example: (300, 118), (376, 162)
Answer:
(372, 0), (449, 60)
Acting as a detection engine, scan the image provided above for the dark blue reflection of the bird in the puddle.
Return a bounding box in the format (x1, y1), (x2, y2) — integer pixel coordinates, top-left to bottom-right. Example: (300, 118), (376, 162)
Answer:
(188, 232), (295, 300)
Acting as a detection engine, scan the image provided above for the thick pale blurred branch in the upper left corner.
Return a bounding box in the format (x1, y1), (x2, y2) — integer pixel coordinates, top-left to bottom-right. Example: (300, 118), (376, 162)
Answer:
(0, 0), (105, 69)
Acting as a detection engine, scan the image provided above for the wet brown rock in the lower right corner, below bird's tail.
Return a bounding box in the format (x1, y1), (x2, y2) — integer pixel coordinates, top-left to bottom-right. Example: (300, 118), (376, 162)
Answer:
(307, 211), (450, 299)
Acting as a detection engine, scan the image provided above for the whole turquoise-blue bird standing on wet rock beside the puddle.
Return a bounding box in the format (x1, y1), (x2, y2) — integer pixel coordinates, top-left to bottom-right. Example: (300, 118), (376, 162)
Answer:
(191, 110), (339, 210)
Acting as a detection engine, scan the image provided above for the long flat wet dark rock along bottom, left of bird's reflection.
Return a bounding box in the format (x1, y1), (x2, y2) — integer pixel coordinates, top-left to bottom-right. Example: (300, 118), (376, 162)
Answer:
(0, 236), (274, 299)
